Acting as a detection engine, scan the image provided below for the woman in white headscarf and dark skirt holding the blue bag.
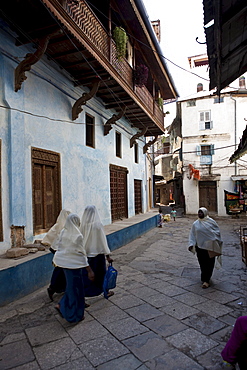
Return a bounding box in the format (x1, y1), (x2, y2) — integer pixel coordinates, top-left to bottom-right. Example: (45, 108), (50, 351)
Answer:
(80, 206), (114, 297)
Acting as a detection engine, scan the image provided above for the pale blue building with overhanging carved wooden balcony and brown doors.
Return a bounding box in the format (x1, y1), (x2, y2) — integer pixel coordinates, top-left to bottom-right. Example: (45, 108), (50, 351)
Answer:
(0, 0), (177, 253)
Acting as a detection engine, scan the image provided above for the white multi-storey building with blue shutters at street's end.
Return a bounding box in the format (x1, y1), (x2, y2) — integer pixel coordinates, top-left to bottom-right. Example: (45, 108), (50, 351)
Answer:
(181, 80), (247, 216)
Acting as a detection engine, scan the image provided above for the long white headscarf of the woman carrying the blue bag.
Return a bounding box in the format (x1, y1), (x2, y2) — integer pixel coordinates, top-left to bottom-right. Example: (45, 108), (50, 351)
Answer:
(80, 206), (111, 257)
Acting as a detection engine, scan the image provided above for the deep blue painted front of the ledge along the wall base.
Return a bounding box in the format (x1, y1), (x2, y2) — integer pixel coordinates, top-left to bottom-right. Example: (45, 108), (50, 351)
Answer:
(0, 215), (157, 307)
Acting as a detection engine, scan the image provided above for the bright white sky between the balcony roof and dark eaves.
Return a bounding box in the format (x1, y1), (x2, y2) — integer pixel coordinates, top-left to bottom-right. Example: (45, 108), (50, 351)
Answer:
(142, 0), (209, 124)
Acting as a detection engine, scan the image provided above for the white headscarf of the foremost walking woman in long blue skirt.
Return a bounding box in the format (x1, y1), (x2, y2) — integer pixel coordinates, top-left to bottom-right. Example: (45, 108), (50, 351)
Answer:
(53, 213), (88, 269)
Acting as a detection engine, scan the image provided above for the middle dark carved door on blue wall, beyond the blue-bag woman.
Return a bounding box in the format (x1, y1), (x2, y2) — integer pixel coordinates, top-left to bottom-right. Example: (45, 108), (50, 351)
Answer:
(110, 165), (128, 222)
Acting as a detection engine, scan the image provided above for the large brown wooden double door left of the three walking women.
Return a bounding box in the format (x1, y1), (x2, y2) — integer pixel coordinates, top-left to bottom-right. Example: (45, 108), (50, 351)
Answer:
(32, 148), (61, 234)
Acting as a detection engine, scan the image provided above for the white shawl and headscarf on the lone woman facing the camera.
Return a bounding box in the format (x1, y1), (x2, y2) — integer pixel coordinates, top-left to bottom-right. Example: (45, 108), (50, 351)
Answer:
(189, 207), (223, 255)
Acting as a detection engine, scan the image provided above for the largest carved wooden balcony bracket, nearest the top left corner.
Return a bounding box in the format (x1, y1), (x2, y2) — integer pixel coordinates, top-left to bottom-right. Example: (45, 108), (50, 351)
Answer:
(15, 31), (62, 92)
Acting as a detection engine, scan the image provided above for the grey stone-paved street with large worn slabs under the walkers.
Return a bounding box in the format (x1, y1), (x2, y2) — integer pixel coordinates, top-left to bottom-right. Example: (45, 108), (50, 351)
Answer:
(0, 217), (247, 370)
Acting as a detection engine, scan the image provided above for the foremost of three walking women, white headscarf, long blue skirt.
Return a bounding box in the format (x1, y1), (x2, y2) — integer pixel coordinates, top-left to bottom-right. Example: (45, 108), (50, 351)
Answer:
(53, 213), (94, 322)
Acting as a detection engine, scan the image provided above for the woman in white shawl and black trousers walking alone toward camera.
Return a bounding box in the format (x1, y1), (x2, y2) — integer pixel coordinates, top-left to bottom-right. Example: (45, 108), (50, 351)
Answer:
(189, 207), (222, 289)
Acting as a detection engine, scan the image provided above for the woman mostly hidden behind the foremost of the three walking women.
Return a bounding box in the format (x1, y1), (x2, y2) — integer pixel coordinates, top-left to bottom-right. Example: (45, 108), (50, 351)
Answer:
(41, 209), (71, 301)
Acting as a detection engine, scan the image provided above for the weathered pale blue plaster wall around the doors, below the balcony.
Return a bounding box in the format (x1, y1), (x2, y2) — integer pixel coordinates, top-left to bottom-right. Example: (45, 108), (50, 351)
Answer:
(0, 31), (147, 253)
